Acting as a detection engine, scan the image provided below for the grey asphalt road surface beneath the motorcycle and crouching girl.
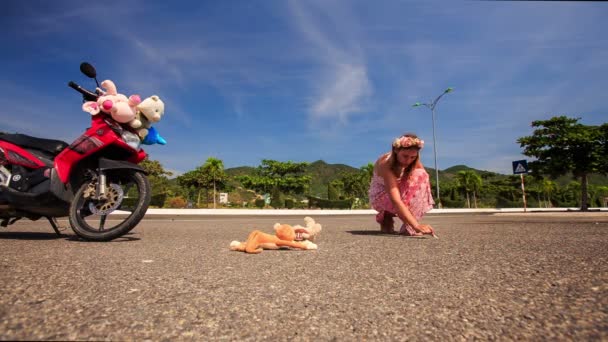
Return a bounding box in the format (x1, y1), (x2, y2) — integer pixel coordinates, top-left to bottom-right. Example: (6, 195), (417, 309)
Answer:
(0, 213), (608, 341)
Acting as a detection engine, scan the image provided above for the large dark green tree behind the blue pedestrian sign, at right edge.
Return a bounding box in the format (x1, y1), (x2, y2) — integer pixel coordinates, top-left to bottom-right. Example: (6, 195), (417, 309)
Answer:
(517, 116), (608, 211)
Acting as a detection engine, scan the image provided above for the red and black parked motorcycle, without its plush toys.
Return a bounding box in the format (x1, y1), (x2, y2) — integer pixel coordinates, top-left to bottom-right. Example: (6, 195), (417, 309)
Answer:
(0, 63), (151, 241)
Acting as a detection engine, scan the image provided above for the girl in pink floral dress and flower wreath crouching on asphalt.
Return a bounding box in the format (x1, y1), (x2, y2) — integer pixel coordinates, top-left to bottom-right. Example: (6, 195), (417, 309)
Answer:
(369, 133), (435, 236)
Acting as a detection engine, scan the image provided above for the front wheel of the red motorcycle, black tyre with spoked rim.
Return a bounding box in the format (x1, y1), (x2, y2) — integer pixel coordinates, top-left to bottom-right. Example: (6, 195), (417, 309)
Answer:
(69, 170), (151, 241)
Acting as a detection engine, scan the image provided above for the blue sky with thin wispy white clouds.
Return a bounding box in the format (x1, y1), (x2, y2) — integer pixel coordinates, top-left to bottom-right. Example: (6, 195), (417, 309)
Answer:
(0, 0), (608, 174)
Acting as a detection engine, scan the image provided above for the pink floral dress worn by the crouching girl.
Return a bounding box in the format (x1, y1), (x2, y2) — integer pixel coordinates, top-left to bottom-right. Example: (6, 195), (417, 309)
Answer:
(369, 169), (435, 235)
